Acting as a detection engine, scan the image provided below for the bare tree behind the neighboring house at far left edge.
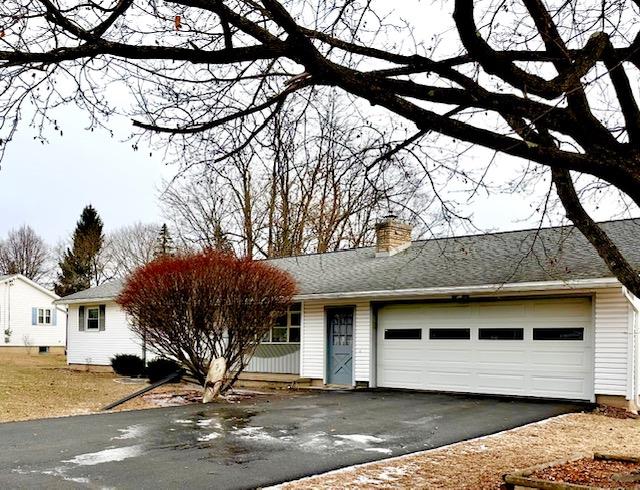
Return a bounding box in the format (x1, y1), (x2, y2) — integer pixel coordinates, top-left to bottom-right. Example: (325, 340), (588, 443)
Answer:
(0, 225), (50, 282)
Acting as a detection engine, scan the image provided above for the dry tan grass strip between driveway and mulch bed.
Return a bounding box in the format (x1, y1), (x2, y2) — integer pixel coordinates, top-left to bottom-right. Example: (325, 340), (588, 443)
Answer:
(282, 414), (640, 490)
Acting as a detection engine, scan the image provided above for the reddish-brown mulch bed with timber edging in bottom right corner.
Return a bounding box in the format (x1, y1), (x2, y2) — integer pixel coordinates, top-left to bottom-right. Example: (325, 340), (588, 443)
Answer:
(528, 458), (640, 489)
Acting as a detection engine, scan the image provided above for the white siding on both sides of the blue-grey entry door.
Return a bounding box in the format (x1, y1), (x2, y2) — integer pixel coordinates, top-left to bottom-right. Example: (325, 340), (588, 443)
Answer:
(300, 300), (371, 382)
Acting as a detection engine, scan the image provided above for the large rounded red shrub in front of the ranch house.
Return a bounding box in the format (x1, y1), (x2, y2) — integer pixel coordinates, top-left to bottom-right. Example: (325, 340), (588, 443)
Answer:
(117, 252), (296, 391)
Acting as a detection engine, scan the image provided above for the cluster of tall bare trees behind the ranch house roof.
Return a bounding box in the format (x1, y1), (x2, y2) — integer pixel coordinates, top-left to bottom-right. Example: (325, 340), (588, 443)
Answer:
(160, 94), (427, 258)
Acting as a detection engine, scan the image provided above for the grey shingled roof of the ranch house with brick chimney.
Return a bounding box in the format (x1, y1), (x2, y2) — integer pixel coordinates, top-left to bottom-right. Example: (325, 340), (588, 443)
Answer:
(55, 219), (640, 302)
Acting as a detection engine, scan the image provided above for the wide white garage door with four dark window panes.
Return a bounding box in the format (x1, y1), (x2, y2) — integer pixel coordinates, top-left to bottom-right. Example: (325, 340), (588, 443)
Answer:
(377, 298), (594, 400)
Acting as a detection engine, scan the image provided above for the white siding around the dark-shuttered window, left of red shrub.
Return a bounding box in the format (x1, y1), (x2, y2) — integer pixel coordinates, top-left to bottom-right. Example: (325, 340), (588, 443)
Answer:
(67, 302), (142, 366)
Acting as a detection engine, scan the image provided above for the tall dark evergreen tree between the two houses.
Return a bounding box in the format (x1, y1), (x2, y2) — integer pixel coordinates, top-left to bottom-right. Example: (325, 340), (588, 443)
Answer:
(54, 205), (104, 296)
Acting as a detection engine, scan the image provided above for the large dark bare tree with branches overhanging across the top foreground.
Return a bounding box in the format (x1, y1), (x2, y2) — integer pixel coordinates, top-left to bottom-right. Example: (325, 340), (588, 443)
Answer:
(0, 0), (640, 295)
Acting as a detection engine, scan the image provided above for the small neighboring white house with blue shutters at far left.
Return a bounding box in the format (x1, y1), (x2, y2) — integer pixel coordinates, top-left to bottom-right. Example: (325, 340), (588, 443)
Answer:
(0, 274), (67, 353)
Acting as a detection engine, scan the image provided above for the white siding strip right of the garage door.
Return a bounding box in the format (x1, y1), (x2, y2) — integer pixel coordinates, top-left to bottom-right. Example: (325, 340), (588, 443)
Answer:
(595, 288), (631, 395)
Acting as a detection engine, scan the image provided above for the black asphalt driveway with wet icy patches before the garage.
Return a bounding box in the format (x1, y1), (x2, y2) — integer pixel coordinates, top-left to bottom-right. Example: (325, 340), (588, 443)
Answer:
(0, 391), (584, 489)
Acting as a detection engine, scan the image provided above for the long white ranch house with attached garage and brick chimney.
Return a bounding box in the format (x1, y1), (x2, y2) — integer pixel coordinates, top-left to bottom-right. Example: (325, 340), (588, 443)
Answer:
(60, 218), (640, 408)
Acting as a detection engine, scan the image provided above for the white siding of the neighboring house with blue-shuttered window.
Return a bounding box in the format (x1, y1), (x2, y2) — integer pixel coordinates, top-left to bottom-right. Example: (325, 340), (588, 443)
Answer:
(0, 277), (66, 347)
